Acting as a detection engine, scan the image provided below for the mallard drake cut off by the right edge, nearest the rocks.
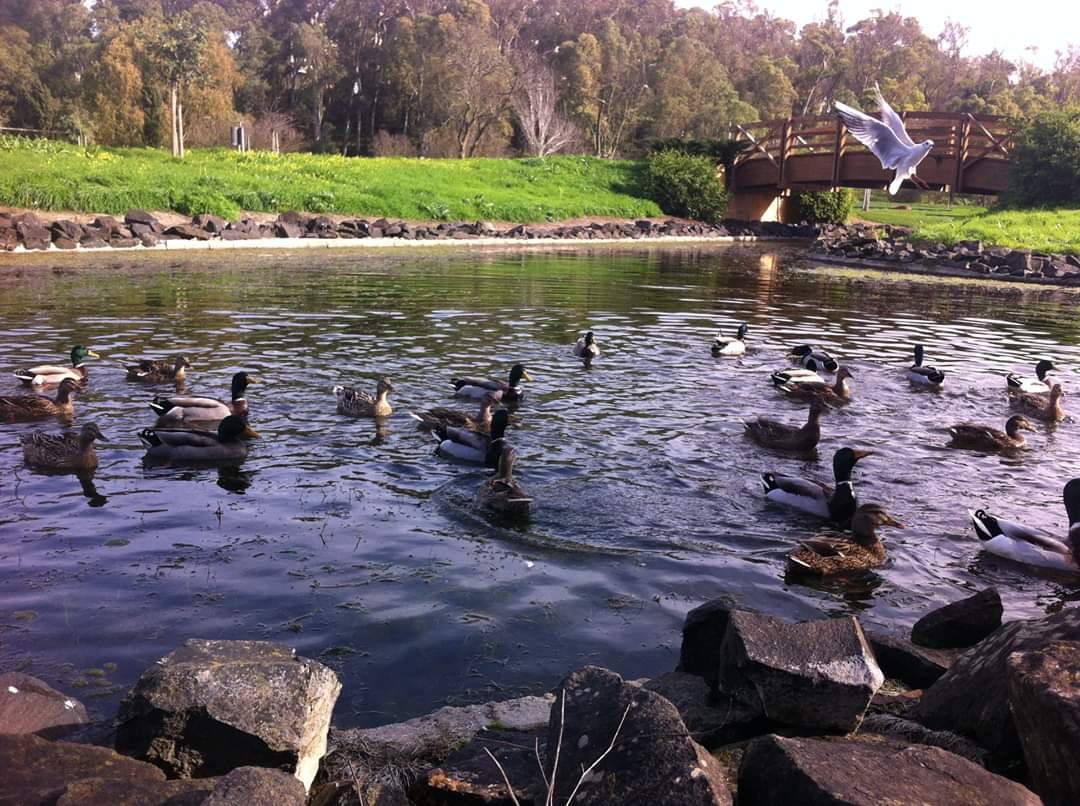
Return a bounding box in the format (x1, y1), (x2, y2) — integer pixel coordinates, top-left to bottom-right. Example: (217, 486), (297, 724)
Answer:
(970, 479), (1080, 573)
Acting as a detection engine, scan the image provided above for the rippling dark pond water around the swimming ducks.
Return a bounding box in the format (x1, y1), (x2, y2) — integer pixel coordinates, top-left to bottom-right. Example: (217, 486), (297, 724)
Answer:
(0, 245), (1080, 726)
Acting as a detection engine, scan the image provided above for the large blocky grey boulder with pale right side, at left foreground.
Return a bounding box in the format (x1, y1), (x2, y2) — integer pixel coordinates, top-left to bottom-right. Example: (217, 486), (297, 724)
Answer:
(117, 640), (341, 788)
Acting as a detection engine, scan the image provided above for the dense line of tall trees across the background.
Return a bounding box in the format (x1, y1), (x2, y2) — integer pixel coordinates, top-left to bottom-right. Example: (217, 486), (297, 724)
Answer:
(0, 0), (1080, 157)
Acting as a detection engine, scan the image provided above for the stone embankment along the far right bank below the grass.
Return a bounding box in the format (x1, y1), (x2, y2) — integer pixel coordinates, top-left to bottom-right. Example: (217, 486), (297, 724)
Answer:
(808, 225), (1080, 285)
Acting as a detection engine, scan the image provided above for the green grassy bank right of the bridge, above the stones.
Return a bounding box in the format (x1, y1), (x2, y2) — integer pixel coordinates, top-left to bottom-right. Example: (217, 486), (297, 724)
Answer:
(854, 196), (1080, 254)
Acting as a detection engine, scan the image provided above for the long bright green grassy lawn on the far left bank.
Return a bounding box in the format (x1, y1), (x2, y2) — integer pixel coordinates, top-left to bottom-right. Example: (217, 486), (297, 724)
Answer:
(0, 137), (661, 223)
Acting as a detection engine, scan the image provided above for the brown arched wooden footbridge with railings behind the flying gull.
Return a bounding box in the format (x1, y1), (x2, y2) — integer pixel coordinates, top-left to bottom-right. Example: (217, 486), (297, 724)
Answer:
(728, 112), (1015, 219)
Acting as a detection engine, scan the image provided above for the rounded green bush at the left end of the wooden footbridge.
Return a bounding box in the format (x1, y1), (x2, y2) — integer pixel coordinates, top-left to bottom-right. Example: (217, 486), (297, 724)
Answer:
(649, 150), (728, 223)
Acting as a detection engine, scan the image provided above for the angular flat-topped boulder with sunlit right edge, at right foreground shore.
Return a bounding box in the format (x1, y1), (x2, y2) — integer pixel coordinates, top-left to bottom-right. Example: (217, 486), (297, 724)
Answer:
(719, 610), (885, 733)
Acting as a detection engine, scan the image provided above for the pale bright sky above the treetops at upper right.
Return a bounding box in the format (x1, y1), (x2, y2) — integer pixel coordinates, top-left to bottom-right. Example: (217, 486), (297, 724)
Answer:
(675, 0), (1080, 69)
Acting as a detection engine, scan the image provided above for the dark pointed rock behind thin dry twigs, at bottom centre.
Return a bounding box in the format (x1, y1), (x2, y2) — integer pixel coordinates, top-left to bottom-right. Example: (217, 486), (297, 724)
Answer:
(546, 667), (731, 806)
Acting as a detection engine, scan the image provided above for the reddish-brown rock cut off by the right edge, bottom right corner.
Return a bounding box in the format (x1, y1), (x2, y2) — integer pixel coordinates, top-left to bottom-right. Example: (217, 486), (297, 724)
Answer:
(1007, 641), (1080, 806)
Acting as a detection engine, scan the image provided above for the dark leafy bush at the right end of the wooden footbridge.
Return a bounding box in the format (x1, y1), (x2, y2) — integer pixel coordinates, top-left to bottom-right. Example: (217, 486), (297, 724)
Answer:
(1005, 107), (1080, 207)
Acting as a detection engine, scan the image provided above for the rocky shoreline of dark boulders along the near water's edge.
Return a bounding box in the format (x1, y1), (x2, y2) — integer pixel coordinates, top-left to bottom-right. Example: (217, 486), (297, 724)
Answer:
(0, 589), (1080, 806)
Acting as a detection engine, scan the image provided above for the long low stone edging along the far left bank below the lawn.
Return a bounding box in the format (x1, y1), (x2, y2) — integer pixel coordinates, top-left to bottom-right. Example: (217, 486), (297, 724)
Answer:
(0, 210), (818, 252)
